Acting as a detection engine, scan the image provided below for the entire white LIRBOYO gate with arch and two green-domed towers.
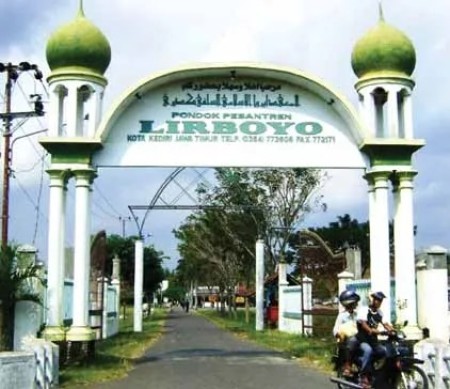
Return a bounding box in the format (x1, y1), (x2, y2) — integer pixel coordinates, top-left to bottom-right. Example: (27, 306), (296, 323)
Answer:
(40, 5), (424, 340)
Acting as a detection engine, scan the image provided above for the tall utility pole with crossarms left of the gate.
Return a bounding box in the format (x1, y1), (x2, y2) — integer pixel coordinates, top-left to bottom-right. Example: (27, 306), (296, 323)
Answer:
(0, 62), (44, 248)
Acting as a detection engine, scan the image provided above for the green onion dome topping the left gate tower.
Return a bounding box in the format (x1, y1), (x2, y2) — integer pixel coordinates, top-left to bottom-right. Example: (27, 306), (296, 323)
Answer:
(46, 6), (111, 77)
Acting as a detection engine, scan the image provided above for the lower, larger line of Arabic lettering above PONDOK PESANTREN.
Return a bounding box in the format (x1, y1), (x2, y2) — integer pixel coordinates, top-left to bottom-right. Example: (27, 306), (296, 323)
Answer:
(162, 93), (300, 108)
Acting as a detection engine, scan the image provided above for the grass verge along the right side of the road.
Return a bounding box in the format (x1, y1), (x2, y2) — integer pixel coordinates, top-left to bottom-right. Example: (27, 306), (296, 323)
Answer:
(196, 309), (335, 373)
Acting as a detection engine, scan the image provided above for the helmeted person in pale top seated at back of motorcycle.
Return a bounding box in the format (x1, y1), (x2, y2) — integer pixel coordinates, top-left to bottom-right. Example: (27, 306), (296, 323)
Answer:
(333, 290), (360, 377)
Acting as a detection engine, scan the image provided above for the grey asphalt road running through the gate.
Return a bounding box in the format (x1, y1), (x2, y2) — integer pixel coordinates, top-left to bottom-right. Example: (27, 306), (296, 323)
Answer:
(89, 309), (336, 389)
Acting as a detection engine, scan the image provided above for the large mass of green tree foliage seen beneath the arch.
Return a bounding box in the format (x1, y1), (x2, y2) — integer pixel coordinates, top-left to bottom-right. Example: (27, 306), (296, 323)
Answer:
(174, 168), (323, 296)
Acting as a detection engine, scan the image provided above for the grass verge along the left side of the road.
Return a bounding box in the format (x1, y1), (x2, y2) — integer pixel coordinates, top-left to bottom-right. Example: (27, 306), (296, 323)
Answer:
(59, 309), (167, 388)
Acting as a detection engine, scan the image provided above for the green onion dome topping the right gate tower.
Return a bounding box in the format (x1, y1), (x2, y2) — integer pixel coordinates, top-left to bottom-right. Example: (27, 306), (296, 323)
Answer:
(352, 15), (416, 79)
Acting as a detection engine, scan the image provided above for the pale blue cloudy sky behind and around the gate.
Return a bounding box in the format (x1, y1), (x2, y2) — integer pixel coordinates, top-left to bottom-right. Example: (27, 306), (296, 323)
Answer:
(0, 0), (450, 268)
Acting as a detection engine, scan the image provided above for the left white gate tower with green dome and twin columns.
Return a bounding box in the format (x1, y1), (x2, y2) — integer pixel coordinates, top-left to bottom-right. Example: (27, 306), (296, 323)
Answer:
(40, 0), (111, 341)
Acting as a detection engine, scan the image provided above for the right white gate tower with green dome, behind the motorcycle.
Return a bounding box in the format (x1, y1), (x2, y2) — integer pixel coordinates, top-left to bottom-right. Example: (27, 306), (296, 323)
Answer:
(352, 5), (424, 334)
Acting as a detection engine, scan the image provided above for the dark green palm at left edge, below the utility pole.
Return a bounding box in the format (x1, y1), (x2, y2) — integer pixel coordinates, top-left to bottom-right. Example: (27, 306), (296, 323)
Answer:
(0, 246), (45, 351)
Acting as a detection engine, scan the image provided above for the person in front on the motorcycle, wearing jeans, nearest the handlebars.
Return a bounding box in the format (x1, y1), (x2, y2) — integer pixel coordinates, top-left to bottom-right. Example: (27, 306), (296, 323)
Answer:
(356, 292), (394, 387)
